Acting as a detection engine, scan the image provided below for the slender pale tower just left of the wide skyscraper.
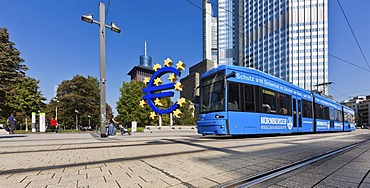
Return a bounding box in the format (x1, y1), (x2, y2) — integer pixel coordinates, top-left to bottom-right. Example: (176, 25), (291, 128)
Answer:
(203, 0), (217, 63)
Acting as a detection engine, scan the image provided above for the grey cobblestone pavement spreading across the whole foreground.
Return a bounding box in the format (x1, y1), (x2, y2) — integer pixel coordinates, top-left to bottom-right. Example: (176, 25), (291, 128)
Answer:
(0, 130), (370, 188)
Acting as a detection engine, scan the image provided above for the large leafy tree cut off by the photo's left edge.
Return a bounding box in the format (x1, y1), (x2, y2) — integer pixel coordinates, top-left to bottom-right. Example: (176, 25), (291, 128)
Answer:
(0, 28), (45, 120)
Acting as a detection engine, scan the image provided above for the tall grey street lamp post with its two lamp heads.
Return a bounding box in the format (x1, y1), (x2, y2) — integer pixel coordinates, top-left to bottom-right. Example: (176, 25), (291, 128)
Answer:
(81, 3), (121, 137)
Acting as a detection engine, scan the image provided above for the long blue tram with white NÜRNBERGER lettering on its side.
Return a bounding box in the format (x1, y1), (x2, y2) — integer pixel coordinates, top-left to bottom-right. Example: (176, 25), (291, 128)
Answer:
(197, 65), (355, 135)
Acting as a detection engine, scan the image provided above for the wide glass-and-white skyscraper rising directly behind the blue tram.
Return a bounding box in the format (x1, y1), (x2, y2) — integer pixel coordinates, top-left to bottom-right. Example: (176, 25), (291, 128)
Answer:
(218, 0), (328, 94)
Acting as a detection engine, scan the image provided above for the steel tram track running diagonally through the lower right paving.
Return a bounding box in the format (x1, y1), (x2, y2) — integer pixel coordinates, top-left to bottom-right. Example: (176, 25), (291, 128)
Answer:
(216, 139), (370, 188)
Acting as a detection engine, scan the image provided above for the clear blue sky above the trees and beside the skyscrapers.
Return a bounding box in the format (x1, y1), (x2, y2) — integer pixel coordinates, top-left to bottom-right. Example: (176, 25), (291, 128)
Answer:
(0, 0), (370, 113)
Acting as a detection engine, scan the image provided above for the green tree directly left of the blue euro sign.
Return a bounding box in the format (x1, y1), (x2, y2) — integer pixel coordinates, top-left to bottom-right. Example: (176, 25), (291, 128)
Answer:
(115, 80), (153, 126)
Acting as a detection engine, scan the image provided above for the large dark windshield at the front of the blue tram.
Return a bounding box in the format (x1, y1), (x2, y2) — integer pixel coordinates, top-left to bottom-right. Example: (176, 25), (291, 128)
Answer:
(200, 72), (225, 113)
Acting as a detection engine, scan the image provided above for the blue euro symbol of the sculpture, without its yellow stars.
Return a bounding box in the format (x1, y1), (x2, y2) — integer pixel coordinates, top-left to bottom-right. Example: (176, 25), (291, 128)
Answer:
(142, 67), (181, 115)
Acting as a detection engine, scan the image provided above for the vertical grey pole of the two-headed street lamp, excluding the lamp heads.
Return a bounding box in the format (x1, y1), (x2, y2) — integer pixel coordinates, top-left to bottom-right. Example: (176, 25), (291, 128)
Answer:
(99, 3), (107, 138)
